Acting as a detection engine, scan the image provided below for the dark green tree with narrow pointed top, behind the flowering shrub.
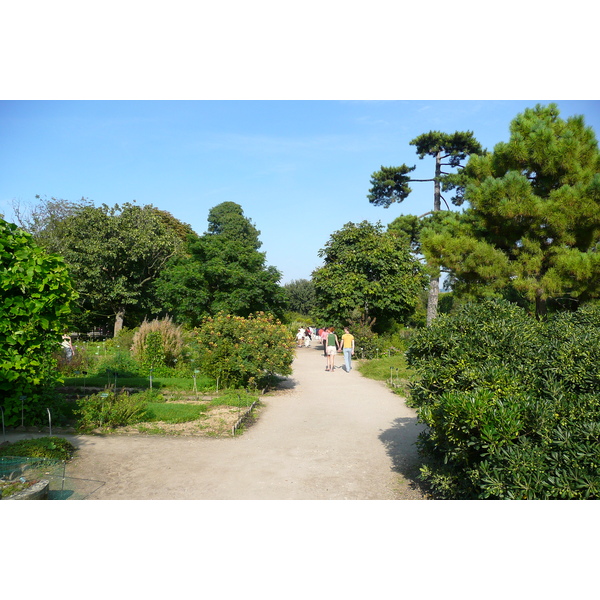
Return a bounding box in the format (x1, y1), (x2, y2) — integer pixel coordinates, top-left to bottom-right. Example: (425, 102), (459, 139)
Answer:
(156, 202), (286, 326)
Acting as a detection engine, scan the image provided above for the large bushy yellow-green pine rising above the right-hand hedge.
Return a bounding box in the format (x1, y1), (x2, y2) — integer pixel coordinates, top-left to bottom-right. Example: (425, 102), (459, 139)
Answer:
(422, 104), (600, 317)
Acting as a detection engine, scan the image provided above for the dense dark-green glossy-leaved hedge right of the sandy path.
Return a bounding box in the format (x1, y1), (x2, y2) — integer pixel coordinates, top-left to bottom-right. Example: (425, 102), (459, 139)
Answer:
(407, 301), (600, 499)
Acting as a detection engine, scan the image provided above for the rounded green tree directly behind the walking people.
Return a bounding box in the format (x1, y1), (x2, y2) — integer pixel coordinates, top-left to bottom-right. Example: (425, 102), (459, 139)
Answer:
(312, 221), (424, 329)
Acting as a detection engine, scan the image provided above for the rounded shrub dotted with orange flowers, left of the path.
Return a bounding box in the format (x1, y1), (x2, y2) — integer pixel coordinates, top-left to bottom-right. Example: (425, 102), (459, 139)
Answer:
(194, 312), (294, 387)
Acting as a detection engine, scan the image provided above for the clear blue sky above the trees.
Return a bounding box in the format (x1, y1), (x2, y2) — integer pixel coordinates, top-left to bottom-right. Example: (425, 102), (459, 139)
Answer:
(0, 100), (600, 283)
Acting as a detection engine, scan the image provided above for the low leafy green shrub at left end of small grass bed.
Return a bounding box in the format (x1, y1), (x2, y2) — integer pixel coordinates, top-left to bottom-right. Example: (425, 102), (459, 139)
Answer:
(75, 388), (147, 431)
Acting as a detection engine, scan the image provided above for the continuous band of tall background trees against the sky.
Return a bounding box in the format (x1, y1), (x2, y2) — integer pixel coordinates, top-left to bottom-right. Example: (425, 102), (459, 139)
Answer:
(4, 104), (600, 334)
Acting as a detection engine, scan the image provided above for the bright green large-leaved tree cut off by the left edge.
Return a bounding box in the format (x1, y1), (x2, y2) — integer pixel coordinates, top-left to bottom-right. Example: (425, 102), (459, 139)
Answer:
(0, 220), (77, 426)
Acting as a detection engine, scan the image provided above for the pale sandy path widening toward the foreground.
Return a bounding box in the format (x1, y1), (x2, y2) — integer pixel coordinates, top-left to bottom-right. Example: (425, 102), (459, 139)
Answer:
(7, 347), (424, 500)
